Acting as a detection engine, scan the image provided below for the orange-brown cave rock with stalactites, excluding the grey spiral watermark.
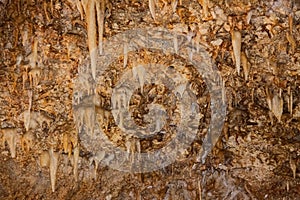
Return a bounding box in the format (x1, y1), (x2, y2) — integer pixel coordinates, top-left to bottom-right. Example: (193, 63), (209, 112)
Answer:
(0, 0), (300, 199)
